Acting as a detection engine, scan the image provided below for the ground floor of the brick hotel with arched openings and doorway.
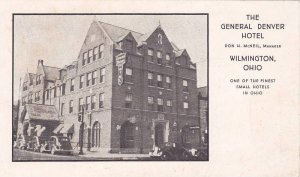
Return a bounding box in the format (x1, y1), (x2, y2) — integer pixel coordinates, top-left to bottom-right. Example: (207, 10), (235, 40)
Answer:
(64, 108), (199, 153)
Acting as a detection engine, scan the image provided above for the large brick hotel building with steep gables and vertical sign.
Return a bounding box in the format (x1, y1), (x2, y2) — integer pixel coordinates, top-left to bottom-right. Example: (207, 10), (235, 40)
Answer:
(20, 18), (199, 153)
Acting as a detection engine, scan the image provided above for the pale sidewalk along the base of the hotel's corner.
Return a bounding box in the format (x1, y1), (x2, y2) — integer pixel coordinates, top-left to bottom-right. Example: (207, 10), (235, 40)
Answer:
(74, 149), (150, 160)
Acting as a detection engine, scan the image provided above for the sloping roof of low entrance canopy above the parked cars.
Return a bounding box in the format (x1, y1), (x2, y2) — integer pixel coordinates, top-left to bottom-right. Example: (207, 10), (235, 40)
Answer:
(23, 104), (61, 121)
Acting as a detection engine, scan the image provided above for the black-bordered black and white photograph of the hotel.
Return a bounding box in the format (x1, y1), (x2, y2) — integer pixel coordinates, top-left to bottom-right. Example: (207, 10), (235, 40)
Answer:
(12, 14), (209, 162)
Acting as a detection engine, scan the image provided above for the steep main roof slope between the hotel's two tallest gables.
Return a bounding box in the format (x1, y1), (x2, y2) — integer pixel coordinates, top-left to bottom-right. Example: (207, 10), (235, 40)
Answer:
(99, 21), (143, 42)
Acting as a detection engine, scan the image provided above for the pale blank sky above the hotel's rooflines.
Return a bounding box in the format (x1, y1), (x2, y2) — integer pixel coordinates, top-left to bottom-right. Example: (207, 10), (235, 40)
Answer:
(14, 15), (207, 99)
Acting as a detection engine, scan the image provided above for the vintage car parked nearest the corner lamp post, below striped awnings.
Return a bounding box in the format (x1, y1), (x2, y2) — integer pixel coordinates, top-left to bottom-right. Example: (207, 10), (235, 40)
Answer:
(40, 136), (73, 155)
